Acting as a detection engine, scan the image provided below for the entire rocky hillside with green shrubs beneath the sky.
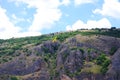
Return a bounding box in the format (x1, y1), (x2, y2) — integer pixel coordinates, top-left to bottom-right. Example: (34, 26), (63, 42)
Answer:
(0, 29), (120, 80)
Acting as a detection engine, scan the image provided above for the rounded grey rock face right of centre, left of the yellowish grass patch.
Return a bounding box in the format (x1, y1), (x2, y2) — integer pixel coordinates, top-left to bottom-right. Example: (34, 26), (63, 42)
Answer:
(64, 51), (83, 73)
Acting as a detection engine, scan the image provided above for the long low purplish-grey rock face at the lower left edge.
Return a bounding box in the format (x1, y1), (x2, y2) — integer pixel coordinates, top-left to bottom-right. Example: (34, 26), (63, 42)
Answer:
(0, 59), (45, 75)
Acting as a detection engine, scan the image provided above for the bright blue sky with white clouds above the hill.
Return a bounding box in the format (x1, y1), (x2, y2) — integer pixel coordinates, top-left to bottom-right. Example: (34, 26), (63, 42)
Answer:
(0, 0), (120, 39)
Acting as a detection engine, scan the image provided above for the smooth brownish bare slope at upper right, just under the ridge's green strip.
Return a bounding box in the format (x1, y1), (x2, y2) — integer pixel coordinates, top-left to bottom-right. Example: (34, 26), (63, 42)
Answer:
(76, 35), (120, 54)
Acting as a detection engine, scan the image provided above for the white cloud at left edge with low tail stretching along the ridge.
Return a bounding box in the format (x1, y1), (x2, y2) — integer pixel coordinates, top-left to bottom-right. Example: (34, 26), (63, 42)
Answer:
(0, 6), (41, 39)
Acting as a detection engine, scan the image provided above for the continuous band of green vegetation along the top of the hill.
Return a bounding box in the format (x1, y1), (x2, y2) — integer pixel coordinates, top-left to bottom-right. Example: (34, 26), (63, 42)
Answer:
(0, 29), (120, 54)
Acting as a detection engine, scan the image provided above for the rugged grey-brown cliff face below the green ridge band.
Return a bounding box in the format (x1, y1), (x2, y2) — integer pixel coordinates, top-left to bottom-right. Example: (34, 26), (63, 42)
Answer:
(0, 35), (120, 80)
